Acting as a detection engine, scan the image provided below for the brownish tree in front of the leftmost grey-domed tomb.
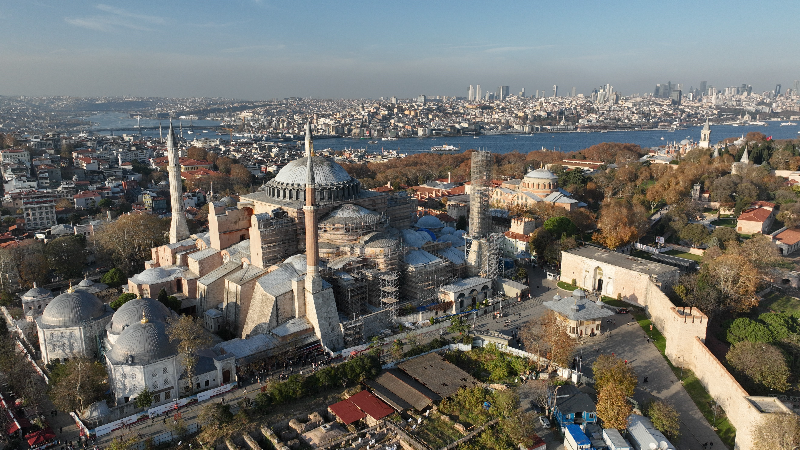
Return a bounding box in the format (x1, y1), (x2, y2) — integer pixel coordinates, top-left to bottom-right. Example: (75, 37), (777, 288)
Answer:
(50, 356), (108, 411)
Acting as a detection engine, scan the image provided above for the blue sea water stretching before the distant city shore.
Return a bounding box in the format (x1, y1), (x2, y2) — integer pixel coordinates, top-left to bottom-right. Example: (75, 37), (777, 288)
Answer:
(86, 113), (800, 154)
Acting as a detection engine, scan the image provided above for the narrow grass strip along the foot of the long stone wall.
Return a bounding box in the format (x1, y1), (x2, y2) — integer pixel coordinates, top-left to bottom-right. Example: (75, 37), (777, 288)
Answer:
(632, 310), (736, 448)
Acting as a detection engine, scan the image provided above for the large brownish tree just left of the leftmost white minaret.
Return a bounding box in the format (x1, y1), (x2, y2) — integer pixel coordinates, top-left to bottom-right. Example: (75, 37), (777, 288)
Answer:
(96, 214), (169, 274)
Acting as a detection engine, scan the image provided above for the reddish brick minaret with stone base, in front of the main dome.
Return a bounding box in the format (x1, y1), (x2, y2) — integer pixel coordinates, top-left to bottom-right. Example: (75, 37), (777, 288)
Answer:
(303, 123), (344, 351)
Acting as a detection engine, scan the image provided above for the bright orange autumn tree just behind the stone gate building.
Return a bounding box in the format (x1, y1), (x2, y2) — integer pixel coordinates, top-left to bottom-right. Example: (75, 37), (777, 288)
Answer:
(592, 200), (649, 250)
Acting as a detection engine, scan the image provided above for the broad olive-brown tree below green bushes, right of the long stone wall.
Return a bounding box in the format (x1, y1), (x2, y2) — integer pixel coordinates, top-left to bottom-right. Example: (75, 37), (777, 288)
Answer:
(725, 341), (789, 392)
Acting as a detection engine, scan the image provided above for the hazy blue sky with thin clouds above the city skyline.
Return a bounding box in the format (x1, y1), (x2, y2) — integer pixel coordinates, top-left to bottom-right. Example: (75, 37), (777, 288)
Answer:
(0, 0), (800, 100)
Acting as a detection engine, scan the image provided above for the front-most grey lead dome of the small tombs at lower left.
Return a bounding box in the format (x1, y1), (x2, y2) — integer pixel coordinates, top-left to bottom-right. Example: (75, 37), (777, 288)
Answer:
(108, 319), (178, 366)
